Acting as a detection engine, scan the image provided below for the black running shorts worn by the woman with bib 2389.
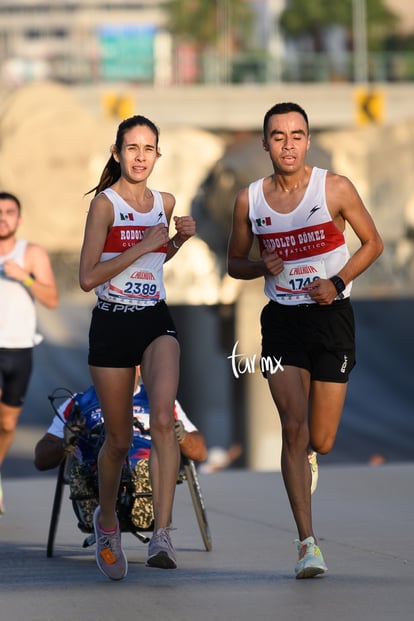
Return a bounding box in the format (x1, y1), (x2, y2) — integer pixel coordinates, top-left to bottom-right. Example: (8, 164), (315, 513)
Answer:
(88, 300), (177, 368)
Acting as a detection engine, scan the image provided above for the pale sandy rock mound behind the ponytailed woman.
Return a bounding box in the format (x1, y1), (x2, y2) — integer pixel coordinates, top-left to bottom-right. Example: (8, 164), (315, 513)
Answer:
(0, 83), (230, 304)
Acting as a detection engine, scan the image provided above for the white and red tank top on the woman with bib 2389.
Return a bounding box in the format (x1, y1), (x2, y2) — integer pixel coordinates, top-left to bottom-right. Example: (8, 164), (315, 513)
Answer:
(95, 188), (168, 306)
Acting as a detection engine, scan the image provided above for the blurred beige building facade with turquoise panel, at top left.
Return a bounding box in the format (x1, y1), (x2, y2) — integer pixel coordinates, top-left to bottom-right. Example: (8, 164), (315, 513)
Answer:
(0, 0), (165, 84)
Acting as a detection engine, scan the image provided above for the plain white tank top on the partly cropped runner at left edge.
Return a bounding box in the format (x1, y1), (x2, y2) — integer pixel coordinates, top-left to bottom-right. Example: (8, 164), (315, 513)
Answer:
(0, 239), (42, 349)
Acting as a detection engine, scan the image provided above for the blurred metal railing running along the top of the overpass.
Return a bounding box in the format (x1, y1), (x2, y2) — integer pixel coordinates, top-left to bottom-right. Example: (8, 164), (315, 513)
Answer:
(0, 49), (414, 86)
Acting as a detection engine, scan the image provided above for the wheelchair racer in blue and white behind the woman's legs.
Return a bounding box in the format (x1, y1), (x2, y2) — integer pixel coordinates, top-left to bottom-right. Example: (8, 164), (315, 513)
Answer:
(34, 367), (207, 532)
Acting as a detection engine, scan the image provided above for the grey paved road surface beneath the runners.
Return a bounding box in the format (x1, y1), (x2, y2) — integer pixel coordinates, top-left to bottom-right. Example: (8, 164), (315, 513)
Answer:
(0, 464), (414, 621)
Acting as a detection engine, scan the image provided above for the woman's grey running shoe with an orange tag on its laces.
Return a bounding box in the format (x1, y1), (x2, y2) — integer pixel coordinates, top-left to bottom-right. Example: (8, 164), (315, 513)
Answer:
(93, 506), (128, 580)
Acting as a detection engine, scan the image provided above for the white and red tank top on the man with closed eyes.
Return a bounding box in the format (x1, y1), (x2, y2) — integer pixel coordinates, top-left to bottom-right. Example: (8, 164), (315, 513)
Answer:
(249, 167), (352, 305)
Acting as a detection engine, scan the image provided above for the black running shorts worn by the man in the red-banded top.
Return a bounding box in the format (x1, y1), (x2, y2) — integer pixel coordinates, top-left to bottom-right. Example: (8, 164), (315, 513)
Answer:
(260, 298), (355, 383)
